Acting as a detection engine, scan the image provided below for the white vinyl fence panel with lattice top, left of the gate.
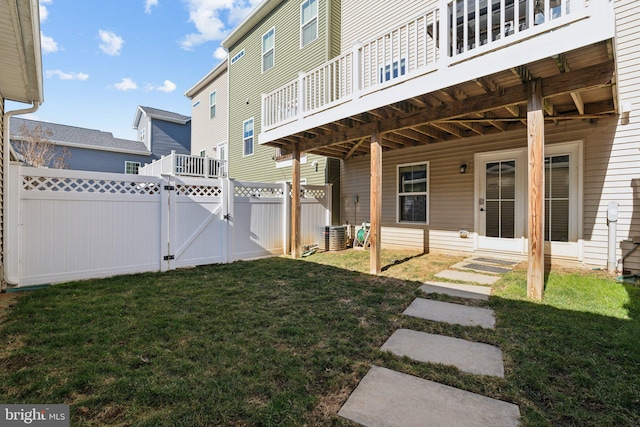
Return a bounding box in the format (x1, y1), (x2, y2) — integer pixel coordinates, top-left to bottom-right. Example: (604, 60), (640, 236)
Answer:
(8, 167), (163, 285)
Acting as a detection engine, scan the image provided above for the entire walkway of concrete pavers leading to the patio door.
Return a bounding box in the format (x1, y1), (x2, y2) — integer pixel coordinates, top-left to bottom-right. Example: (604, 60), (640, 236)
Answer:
(338, 258), (520, 427)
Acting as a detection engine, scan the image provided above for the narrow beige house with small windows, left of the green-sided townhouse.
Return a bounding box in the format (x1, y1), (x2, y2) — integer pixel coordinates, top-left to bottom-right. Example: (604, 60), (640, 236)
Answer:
(185, 60), (229, 160)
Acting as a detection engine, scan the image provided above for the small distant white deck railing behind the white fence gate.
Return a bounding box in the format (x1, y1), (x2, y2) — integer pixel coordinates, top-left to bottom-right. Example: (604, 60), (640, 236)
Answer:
(138, 151), (227, 178)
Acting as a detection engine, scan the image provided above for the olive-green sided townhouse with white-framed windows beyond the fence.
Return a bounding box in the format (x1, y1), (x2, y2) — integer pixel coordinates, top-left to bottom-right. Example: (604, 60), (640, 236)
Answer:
(220, 0), (341, 187)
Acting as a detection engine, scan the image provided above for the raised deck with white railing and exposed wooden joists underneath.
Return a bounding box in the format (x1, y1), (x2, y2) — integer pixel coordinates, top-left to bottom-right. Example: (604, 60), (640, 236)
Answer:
(259, 0), (619, 159)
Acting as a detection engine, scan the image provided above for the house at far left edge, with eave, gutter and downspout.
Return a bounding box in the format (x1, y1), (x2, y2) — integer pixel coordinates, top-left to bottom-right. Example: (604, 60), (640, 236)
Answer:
(0, 0), (44, 288)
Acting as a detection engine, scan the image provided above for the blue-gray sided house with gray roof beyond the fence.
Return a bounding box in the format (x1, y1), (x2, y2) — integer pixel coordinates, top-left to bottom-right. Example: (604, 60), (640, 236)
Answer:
(11, 107), (191, 173)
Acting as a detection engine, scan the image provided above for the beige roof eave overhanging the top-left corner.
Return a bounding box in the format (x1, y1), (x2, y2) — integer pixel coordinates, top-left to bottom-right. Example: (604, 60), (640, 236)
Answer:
(0, 0), (44, 103)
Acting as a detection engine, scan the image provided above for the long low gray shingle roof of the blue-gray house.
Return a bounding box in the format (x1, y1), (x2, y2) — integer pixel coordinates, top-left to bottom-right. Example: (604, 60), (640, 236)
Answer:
(11, 117), (151, 155)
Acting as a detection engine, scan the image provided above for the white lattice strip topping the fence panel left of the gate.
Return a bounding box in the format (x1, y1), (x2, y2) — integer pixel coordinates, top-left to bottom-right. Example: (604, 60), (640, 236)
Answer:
(22, 175), (160, 195)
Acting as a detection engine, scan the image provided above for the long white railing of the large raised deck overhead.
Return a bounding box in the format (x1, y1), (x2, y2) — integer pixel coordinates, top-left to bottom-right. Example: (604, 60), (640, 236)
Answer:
(262, 0), (584, 131)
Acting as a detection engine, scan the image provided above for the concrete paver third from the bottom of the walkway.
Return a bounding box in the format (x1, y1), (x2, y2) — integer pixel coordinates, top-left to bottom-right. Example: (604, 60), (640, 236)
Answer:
(402, 298), (496, 328)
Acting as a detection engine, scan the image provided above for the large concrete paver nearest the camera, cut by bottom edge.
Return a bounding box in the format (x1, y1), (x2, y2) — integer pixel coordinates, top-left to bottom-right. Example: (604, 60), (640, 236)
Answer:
(338, 366), (520, 427)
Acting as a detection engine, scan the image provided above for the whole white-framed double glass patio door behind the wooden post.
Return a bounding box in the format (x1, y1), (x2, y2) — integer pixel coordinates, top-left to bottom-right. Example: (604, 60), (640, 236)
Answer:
(475, 142), (582, 260)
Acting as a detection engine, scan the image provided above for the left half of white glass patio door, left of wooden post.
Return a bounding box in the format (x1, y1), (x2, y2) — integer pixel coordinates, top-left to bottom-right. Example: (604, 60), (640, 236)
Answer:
(476, 150), (527, 253)
